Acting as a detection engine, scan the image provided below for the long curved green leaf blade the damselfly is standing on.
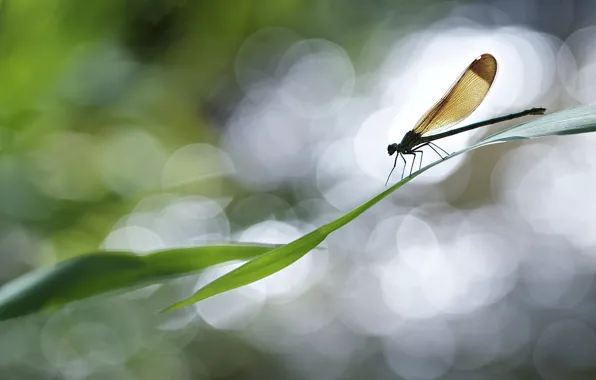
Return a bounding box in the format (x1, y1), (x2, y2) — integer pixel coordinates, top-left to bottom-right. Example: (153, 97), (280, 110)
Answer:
(164, 106), (596, 311)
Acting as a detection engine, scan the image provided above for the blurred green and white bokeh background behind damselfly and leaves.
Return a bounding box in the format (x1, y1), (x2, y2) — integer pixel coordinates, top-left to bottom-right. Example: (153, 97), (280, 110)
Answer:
(0, 0), (596, 380)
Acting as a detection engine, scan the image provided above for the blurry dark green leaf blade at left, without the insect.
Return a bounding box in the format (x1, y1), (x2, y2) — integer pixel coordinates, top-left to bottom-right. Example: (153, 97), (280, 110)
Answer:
(0, 244), (278, 320)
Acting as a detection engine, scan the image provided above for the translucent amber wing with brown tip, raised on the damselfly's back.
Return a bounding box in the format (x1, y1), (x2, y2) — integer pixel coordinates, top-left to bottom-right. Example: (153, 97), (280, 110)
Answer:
(414, 54), (497, 135)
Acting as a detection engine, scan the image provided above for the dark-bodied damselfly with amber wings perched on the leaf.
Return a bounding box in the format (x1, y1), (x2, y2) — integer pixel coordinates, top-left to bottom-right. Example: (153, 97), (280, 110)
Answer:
(385, 54), (546, 186)
